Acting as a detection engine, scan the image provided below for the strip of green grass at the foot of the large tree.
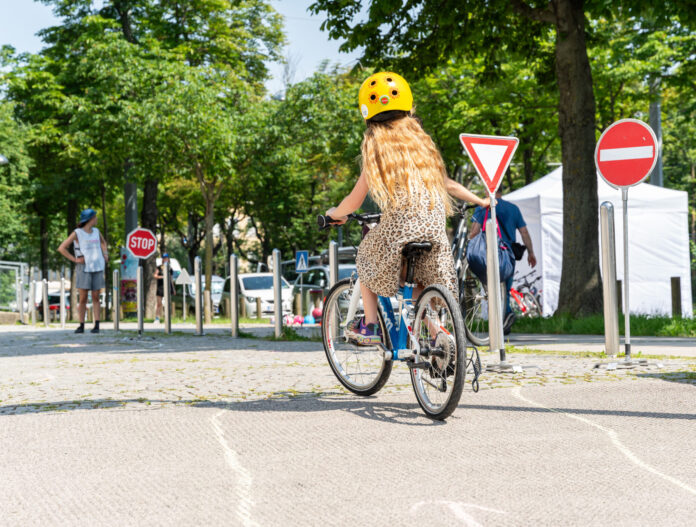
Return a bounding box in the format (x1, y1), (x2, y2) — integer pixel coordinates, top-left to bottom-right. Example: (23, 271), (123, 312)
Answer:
(513, 315), (696, 337)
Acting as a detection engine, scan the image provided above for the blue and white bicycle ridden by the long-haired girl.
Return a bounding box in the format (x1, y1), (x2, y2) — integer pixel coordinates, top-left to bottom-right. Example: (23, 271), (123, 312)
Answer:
(317, 213), (480, 420)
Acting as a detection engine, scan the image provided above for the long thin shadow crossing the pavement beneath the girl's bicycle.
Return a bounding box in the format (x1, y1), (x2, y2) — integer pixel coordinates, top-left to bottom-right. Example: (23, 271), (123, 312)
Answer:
(0, 392), (696, 426)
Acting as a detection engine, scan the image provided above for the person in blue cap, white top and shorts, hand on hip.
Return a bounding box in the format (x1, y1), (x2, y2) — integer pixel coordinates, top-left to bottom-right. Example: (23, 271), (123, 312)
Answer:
(58, 209), (108, 333)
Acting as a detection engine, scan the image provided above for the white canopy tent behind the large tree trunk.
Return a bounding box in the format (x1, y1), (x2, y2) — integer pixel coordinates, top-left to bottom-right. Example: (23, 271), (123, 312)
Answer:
(503, 167), (692, 317)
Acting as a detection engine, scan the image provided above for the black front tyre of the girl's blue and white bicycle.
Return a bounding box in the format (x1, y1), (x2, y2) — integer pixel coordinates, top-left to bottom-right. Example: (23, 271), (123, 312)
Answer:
(321, 278), (393, 396)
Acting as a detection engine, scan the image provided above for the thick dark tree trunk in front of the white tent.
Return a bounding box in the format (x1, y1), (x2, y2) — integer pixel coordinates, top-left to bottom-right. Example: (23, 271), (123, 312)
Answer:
(555, 0), (602, 315)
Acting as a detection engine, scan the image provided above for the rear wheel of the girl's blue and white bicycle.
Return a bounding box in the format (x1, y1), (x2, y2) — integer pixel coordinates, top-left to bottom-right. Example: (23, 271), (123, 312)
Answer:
(411, 285), (466, 420)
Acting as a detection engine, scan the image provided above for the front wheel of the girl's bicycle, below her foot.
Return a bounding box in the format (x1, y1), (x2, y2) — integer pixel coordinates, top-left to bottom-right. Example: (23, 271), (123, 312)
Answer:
(321, 278), (393, 395)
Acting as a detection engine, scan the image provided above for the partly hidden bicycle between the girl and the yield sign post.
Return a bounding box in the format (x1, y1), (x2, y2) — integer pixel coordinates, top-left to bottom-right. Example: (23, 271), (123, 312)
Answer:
(452, 205), (490, 346)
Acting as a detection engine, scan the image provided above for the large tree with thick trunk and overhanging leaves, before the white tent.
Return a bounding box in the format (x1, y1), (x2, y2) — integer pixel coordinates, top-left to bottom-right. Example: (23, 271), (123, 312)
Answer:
(310, 0), (696, 314)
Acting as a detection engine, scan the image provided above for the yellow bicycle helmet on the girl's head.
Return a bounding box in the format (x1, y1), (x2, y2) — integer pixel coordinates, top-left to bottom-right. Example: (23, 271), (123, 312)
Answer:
(358, 71), (413, 121)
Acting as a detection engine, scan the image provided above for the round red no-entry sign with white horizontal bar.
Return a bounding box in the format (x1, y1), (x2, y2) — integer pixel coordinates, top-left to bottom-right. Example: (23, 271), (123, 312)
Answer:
(595, 119), (657, 188)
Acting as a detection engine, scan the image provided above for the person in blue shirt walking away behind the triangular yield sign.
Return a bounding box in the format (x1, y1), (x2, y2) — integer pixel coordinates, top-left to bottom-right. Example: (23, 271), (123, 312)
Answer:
(469, 189), (536, 330)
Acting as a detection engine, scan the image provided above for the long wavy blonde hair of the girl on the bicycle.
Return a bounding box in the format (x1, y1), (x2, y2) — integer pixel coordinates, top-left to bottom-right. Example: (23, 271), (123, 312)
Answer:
(361, 113), (454, 216)
